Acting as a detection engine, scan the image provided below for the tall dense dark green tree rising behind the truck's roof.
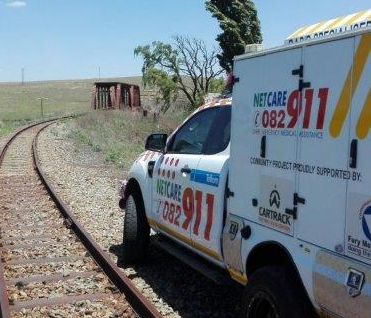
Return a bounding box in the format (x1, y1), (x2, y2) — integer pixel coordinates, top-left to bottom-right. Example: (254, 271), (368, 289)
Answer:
(205, 0), (262, 73)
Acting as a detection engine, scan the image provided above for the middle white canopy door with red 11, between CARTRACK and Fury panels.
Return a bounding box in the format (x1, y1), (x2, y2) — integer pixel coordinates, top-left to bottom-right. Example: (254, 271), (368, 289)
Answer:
(296, 38), (354, 251)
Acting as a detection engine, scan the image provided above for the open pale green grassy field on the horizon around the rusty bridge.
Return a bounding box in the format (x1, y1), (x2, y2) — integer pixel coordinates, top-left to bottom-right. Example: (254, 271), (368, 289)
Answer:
(0, 77), (145, 136)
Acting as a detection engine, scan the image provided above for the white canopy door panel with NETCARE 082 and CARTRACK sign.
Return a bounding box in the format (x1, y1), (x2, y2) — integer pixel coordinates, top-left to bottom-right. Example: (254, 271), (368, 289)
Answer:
(228, 48), (302, 236)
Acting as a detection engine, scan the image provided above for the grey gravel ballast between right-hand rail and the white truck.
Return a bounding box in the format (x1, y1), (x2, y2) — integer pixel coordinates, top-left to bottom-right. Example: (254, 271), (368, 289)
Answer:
(38, 120), (241, 317)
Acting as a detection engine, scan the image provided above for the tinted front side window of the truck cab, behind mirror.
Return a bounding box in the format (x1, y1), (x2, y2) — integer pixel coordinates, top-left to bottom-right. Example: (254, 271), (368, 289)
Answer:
(168, 107), (219, 154)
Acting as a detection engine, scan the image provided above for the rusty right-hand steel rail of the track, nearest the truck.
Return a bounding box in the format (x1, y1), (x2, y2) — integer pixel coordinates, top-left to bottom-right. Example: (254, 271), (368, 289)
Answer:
(32, 123), (163, 318)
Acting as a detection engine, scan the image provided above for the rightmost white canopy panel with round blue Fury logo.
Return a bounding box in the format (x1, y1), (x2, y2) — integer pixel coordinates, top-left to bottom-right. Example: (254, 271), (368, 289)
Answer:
(345, 33), (371, 264)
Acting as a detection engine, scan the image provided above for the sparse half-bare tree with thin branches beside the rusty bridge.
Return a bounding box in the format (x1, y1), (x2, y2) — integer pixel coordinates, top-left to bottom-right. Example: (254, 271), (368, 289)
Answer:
(134, 36), (223, 112)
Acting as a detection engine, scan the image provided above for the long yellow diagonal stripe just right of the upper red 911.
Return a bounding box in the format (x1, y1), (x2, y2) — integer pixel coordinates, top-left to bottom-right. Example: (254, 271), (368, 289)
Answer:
(330, 34), (371, 138)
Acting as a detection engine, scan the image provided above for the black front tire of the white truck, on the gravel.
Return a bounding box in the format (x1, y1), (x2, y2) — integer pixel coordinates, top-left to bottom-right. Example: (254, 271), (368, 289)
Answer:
(122, 192), (150, 264)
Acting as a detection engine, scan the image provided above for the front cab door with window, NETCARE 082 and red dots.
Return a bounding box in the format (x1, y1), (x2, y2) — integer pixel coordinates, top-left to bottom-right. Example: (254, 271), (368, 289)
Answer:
(152, 108), (222, 250)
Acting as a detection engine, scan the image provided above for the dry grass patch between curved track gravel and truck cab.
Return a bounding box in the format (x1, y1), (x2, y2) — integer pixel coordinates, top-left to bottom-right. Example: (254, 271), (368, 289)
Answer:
(70, 111), (185, 170)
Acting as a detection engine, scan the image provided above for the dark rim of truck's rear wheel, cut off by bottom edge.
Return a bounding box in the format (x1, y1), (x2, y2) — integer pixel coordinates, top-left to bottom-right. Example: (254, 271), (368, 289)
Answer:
(247, 292), (279, 318)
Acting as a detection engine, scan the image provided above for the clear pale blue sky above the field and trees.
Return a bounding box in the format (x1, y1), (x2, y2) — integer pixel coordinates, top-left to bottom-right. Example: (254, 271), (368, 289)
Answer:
(0, 0), (371, 82)
